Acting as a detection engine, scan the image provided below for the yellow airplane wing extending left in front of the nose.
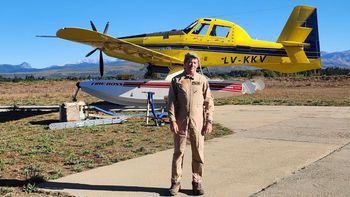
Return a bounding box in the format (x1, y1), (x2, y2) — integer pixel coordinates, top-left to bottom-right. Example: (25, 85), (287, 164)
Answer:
(56, 28), (183, 67)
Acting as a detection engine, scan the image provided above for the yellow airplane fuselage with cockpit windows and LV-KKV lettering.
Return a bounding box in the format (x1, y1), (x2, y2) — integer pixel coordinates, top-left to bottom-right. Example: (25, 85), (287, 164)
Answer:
(115, 18), (319, 72)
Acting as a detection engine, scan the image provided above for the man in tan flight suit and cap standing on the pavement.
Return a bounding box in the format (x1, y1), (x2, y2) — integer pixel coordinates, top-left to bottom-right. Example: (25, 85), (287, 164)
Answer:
(168, 53), (214, 195)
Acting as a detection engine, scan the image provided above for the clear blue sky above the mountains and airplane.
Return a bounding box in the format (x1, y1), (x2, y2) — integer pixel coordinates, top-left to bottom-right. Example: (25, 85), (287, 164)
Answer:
(0, 0), (350, 68)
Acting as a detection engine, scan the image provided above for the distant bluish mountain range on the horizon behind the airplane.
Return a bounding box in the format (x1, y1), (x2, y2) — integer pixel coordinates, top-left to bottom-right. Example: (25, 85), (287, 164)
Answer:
(0, 50), (350, 78)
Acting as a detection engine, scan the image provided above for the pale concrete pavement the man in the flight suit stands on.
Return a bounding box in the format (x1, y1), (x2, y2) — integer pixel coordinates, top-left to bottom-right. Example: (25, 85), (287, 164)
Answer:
(42, 105), (350, 196)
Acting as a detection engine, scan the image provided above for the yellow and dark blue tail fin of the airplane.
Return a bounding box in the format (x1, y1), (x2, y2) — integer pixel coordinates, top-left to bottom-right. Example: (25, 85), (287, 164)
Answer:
(277, 6), (321, 72)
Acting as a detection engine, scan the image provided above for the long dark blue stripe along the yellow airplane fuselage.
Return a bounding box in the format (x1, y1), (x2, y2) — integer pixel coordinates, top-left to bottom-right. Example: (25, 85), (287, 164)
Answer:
(141, 44), (318, 58)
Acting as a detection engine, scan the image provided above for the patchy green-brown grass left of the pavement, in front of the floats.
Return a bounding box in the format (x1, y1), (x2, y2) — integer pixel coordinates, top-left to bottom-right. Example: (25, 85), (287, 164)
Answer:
(0, 113), (232, 195)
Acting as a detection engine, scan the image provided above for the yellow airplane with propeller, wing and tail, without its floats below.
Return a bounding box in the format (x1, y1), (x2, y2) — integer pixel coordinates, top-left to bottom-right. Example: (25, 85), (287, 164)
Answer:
(56, 6), (321, 76)
